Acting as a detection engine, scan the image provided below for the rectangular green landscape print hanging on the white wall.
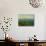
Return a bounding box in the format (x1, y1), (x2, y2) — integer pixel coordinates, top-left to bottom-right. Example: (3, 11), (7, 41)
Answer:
(18, 14), (34, 26)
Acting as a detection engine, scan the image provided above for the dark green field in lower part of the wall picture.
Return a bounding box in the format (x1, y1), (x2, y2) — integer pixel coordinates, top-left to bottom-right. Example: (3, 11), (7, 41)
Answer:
(18, 19), (34, 26)
